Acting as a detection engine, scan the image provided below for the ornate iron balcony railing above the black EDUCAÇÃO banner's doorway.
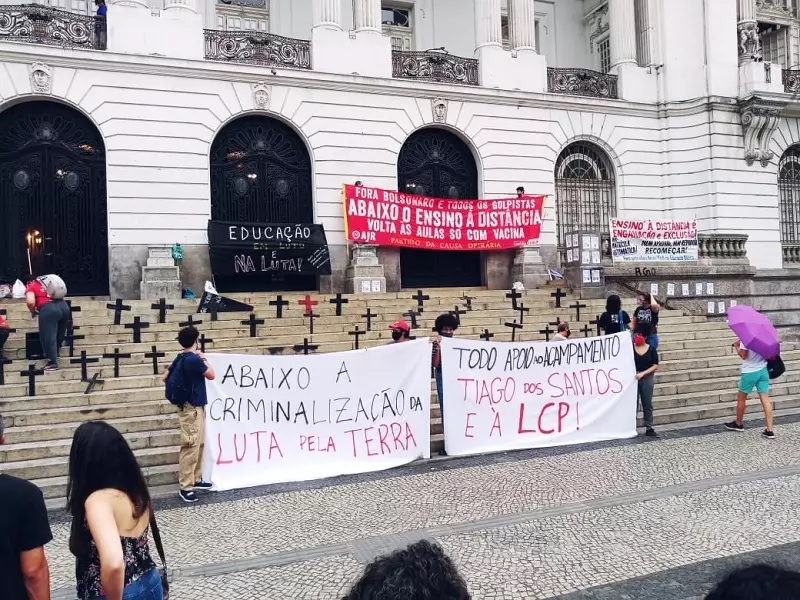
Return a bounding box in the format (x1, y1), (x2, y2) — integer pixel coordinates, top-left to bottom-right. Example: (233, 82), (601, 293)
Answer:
(204, 29), (311, 69)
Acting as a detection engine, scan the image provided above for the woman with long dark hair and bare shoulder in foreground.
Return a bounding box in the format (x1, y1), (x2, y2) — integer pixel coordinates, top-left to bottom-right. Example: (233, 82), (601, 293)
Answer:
(67, 421), (163, 600)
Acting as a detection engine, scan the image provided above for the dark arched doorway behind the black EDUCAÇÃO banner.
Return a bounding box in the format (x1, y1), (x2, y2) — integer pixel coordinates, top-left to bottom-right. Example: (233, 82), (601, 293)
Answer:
(211, 115), (317, 292)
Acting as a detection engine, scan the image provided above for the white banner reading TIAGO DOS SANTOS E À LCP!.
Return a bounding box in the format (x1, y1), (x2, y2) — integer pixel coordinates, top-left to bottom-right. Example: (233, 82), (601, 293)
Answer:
(442, 332), (637, 456)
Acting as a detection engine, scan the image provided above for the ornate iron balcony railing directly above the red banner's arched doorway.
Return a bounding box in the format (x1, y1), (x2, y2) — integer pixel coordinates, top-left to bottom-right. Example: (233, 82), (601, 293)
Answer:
(392, 50), (480, 85)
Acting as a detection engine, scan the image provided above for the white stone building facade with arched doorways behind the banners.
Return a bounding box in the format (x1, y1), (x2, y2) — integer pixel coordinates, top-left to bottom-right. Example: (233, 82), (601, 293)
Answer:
(0, 0), (800, 297)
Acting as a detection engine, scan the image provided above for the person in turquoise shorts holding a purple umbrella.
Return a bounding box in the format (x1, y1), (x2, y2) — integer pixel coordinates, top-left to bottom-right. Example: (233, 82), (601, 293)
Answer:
(725, 306), (780, 440)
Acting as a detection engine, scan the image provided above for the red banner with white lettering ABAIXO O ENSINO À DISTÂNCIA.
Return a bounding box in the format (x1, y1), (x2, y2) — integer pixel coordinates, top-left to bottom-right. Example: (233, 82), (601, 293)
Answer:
(344, 185), (544, 250)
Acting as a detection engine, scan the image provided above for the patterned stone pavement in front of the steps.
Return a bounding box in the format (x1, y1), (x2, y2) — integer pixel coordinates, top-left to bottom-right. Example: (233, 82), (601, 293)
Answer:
(48, 420), (800, 600)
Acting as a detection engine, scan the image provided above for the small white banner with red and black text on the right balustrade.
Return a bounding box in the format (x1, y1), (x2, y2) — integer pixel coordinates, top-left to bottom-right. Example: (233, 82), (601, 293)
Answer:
(611, 219), (698, 262)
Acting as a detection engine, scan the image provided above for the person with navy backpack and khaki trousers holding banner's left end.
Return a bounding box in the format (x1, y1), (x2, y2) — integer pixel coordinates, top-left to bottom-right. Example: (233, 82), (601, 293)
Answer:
(162, 327), (216, 503)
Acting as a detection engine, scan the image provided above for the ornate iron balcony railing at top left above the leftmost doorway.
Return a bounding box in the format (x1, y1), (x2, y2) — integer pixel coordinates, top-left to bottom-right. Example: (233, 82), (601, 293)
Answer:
(0, 4), (106, 50)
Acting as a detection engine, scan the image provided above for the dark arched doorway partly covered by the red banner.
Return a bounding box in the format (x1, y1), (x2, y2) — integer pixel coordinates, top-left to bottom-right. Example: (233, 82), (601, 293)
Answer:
(397, 128), (482, 288)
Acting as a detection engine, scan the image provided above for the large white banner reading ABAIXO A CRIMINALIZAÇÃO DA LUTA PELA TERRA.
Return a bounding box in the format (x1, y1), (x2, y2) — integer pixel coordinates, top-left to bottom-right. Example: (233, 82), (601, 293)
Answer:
(203, 340), (431, 490)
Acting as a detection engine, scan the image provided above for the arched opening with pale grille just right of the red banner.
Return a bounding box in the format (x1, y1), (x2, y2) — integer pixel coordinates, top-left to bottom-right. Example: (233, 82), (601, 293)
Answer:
(555, 141), (617, 264)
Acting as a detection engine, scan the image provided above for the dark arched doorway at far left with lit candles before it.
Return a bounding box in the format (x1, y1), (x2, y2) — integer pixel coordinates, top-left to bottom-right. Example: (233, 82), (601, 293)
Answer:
(0, 101), (108, 296)
